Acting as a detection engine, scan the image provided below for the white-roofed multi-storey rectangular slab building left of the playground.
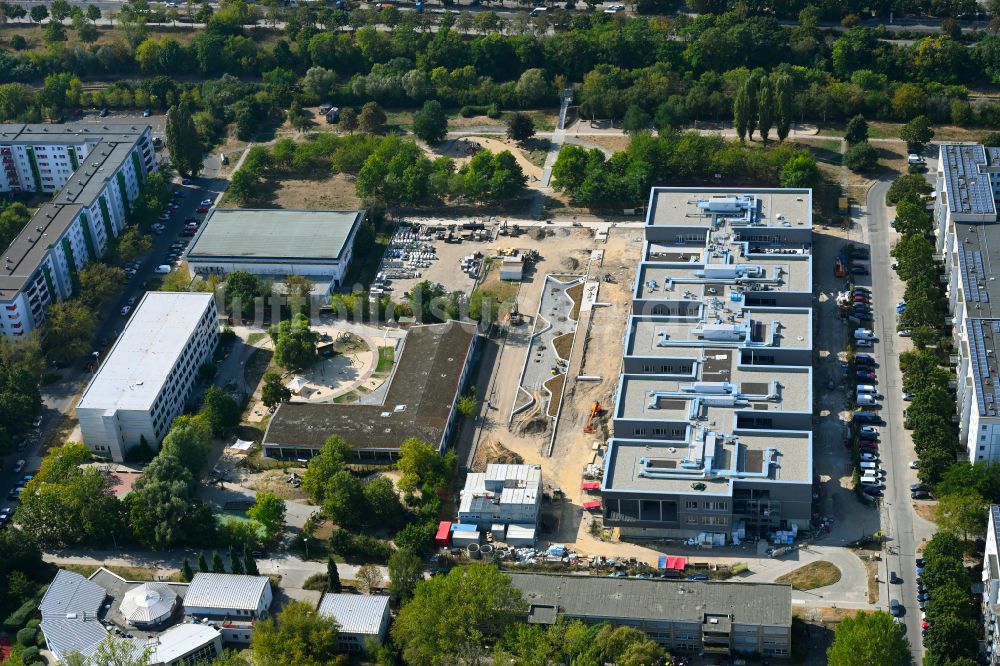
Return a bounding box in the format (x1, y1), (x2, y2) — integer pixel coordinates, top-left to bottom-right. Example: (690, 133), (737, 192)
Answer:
(76, 291), (218, 462)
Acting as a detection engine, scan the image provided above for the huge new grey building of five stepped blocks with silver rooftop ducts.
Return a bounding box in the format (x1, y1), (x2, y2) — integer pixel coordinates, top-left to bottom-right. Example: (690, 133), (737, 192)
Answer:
(601, 188), (813, 544)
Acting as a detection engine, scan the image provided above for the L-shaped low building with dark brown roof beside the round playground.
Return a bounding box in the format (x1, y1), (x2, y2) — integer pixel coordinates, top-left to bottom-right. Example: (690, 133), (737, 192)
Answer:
(263, 321), (480, 462)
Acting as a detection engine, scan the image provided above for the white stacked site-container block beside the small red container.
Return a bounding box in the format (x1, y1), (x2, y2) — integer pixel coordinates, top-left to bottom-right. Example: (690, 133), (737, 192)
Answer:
(458, 463), (542, 530)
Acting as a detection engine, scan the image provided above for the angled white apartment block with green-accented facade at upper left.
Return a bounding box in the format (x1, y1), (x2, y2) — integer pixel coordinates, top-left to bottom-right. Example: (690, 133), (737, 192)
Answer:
(0, 123), (156, 337)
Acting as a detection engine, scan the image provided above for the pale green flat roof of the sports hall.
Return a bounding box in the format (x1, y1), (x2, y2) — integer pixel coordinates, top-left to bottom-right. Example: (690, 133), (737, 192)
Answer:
(188, 208), (365, 261)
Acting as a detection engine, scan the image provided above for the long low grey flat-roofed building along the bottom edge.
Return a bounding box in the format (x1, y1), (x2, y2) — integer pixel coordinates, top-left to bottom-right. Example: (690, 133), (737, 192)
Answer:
(508, 573), (792, 658)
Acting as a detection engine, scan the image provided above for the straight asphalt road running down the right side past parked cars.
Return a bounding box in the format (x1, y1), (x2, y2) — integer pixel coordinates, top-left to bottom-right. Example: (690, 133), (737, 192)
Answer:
(861, 172), (927, 664)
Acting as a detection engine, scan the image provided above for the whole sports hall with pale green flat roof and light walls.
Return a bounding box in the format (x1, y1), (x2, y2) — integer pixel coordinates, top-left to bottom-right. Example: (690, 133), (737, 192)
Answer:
(185, 208), (365, 291)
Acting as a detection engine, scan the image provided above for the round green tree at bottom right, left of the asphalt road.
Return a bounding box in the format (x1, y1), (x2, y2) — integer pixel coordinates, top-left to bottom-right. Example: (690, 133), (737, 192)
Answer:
(826, 611), (910, 666)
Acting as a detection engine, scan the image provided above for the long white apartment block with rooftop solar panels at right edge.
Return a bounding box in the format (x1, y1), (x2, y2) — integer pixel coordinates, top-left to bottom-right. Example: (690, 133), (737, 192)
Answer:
(934, 144), (1000, 462)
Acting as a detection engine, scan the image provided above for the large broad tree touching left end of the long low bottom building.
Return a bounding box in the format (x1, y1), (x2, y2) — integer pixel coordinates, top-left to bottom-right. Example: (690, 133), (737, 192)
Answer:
(392, 565), (525, 665)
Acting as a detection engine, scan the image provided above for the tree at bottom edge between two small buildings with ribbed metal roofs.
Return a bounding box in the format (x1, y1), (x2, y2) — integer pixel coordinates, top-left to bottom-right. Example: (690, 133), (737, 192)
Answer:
(250, 601), (337, 666)
